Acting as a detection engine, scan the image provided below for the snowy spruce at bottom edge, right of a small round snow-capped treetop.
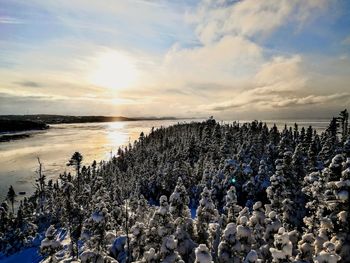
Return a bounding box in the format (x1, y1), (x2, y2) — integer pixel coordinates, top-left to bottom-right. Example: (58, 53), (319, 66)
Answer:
(218, 223), (241, 263)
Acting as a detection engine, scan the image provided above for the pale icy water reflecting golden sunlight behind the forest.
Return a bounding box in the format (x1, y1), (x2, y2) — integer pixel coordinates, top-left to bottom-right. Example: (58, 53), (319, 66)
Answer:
(0, 120), (329, 201)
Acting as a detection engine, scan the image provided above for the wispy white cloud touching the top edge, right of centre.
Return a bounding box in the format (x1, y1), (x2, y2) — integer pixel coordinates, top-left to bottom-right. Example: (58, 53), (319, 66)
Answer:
(189, 0), (331, 43)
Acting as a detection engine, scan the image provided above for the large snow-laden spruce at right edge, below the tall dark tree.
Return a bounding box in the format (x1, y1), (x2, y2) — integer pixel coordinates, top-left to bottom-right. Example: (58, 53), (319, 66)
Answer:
(303, 155), (349, 253)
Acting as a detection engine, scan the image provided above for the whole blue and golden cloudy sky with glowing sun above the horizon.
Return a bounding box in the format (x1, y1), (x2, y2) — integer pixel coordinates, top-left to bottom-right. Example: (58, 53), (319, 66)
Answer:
(0, 0), (350, 119)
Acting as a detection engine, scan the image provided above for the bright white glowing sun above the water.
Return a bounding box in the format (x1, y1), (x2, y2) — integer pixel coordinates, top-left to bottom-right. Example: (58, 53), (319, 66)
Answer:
(89, 51), (137, 90)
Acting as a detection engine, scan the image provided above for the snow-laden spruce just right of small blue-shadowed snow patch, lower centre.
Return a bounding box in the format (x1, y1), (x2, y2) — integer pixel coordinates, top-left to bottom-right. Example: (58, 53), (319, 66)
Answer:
(196, 187), (219, 245)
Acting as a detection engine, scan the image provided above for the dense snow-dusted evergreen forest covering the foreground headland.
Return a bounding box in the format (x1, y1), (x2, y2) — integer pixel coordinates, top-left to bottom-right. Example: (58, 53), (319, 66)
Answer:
(0, 110), (350, 263)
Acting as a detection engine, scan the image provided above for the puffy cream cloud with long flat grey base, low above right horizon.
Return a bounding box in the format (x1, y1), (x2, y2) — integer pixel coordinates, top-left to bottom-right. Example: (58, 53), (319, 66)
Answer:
(201, 55), (350, 112)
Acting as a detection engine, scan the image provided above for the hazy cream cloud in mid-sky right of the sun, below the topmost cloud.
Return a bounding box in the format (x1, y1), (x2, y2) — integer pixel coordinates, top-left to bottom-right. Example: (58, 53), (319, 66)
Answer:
(162, 36), (262, 83)
